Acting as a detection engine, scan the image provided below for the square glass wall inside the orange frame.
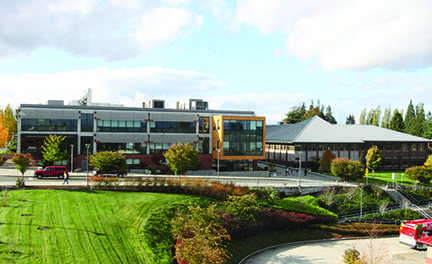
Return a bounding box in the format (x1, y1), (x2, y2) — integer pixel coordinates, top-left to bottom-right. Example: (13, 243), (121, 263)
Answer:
(223, 120), (264, 156)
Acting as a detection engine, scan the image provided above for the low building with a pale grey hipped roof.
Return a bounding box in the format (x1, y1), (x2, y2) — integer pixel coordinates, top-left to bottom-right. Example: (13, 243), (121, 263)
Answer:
(266, 116), (431, 169)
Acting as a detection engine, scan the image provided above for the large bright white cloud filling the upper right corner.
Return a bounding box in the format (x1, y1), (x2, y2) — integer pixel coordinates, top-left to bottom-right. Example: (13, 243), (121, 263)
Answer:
(236, 0), (432, 70)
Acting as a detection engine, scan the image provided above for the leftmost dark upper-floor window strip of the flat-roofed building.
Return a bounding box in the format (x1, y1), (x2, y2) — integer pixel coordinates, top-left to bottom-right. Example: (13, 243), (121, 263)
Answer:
(21, 118), (77, 131)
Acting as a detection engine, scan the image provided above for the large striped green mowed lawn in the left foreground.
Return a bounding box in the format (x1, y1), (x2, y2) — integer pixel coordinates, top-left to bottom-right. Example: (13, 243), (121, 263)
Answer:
(0, 190), (202, 263)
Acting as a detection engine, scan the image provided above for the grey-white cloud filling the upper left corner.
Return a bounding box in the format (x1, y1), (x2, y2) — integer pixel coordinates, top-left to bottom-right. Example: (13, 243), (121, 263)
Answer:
(0, 0), (203, 60)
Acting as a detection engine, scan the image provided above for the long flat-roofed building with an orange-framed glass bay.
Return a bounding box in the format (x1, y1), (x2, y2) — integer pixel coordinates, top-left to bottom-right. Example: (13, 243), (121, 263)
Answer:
(17, 98), (265, 171)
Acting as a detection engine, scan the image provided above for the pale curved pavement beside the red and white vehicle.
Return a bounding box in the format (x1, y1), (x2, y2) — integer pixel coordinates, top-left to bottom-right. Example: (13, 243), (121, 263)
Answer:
(241, 237), (426, 264)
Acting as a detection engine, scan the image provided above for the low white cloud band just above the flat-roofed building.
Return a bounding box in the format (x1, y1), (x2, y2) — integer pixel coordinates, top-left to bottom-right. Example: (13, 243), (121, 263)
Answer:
(0, 67), (225, 108)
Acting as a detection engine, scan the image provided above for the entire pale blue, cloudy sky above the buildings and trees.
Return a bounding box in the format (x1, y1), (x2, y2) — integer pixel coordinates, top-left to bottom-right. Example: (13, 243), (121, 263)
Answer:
(0, 0), (432, 124)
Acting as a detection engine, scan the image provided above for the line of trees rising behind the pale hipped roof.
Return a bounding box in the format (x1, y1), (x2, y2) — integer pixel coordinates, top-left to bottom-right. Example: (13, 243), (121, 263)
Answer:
(283, 100), (432, 139)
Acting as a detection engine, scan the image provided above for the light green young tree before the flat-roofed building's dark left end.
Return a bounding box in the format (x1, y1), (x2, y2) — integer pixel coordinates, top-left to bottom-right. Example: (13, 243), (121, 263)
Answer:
(42, 135), (68, 165)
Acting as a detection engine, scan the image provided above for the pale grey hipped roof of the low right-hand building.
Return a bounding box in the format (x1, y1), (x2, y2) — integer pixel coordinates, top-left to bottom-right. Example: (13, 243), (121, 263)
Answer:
(266, 116), (430, 143)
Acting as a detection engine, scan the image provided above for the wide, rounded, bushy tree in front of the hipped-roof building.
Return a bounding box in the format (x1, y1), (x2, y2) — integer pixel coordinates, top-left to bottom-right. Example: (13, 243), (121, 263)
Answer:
(331, 158), (364, 181)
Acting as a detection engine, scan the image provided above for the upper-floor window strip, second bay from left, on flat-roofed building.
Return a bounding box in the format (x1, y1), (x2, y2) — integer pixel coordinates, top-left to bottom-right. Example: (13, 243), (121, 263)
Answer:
(97, 120), (147, 132)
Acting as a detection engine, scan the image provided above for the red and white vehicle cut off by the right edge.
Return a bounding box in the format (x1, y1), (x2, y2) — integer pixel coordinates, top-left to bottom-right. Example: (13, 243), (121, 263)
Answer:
(399, 219), (432, 249)
